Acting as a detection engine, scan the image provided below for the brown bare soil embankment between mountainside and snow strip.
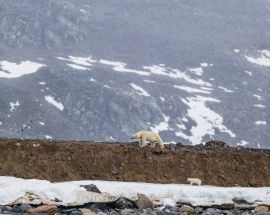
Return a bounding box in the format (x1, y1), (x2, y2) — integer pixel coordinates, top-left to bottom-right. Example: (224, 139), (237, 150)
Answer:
(0, 139), (270, 186)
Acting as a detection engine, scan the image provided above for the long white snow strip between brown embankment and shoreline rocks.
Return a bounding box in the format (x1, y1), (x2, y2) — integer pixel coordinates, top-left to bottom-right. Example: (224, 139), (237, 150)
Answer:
(0, 176), (270, 206)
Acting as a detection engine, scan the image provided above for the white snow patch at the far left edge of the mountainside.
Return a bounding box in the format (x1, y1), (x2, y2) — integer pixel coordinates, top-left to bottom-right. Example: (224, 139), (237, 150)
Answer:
(0, 61), (45, 78)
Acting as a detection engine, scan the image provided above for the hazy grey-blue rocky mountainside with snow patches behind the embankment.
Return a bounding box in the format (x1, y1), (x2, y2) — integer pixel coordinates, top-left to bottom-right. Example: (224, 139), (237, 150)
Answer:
(0, 0), (270, 148)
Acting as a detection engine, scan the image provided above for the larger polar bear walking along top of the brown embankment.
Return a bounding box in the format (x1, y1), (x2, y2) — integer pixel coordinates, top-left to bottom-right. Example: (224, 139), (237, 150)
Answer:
(131, 131), (164, 149)
